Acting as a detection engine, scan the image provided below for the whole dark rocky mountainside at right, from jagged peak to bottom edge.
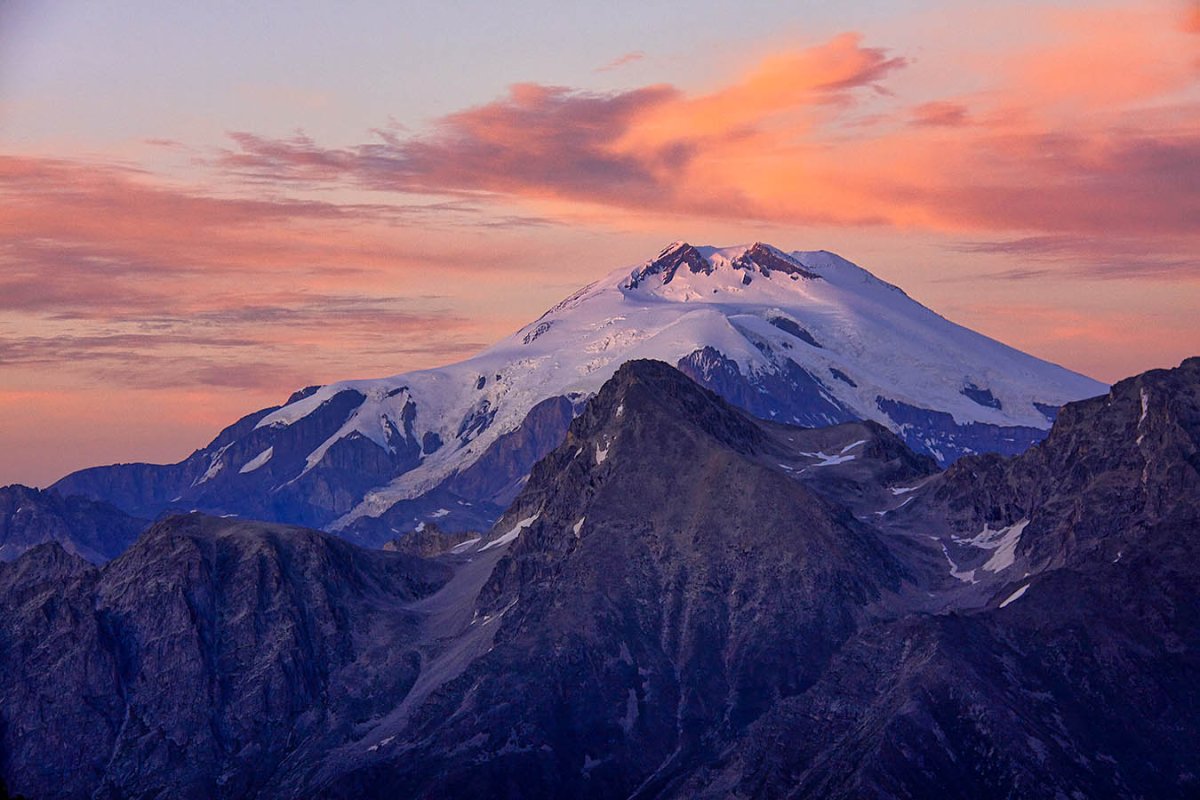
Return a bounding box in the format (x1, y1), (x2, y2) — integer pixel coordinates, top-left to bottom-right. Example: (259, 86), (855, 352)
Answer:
(678, 359), (1200, 798)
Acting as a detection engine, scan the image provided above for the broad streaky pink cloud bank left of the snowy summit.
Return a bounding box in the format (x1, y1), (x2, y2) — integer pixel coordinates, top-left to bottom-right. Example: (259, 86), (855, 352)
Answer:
(0, 156), (552, 393)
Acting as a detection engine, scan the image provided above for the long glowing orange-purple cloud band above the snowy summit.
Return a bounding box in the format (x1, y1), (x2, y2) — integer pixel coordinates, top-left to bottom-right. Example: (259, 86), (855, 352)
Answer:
(216, 8), (1200, 253)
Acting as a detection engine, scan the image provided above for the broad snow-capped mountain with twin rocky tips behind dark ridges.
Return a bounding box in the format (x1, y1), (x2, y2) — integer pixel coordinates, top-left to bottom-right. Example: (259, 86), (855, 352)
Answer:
(58, 242), (1106, 543)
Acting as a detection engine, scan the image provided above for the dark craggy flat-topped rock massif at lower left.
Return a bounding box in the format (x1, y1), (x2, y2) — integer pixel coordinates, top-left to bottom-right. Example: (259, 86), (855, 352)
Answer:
(0, 515), (446, 798)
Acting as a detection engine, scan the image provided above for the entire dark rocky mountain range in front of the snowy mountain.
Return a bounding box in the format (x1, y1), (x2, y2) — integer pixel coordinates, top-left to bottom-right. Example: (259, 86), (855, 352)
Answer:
(0, 359), (1200, 798)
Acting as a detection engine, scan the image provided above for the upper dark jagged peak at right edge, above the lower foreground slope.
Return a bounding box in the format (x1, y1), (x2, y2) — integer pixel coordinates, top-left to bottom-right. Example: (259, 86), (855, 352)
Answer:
(912, 359), (1200, 573)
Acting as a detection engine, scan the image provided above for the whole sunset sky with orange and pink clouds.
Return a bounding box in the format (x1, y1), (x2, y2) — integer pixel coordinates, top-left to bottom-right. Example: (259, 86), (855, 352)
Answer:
(0, 0), (1200, 486)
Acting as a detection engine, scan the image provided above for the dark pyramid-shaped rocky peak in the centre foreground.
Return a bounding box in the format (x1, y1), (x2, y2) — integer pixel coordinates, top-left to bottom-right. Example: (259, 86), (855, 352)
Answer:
(328, 362), (902, 796)
